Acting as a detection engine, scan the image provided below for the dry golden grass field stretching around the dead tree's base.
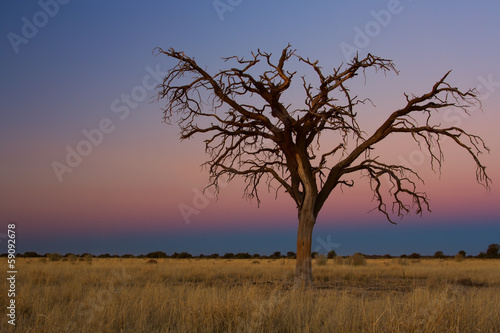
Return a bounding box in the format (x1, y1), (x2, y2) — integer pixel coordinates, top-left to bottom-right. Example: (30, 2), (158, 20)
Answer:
(0, 258), (500, 333)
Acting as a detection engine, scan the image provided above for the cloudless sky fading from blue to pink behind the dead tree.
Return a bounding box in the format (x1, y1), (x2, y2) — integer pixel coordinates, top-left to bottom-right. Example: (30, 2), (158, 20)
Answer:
(0, 0), (500, 255)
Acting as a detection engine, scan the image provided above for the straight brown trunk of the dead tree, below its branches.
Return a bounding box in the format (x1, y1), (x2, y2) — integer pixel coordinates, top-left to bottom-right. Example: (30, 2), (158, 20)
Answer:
(295, 198), (316, 288)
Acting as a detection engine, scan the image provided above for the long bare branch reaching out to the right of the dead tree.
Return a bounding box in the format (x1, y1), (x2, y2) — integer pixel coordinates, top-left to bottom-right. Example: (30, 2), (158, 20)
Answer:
(316, 72), (491, 212)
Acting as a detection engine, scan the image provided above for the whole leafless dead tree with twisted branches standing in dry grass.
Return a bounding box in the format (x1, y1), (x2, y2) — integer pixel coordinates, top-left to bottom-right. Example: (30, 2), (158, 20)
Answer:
(155, 45), (490, 285)
